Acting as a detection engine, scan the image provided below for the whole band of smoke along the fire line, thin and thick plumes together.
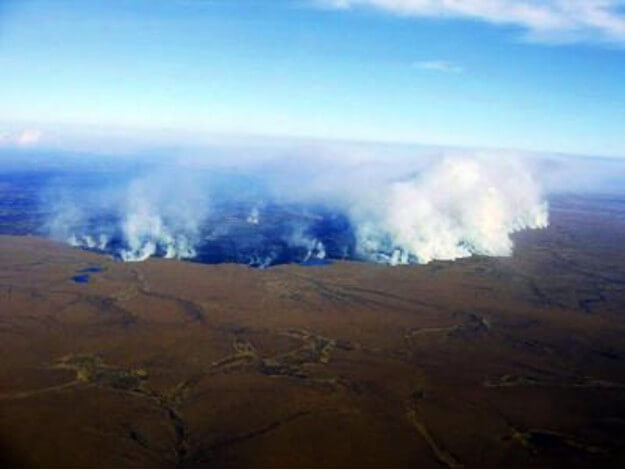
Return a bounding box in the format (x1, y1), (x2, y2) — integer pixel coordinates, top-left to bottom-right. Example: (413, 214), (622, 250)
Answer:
(40, 147), (549, 267)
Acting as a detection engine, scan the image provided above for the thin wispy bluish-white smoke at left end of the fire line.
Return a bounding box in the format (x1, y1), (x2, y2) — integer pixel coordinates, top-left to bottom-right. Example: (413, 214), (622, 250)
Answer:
(46, 167), (208, 261)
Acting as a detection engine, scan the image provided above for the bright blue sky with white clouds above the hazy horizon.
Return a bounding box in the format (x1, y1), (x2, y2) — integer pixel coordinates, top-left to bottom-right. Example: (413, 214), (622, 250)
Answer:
(0, 0), (625, 157)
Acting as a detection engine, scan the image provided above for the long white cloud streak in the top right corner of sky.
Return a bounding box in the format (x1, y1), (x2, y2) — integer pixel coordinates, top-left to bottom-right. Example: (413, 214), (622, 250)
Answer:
(322, 0), (625, 43)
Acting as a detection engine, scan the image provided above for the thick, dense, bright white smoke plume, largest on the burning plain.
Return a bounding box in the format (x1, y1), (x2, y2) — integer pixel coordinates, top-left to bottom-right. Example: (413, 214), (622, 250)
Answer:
(349, 157), (548, 265)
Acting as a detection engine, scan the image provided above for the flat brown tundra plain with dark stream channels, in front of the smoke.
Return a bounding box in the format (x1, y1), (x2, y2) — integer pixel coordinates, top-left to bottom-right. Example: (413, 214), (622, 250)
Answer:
(0, 196), (625, 467)
